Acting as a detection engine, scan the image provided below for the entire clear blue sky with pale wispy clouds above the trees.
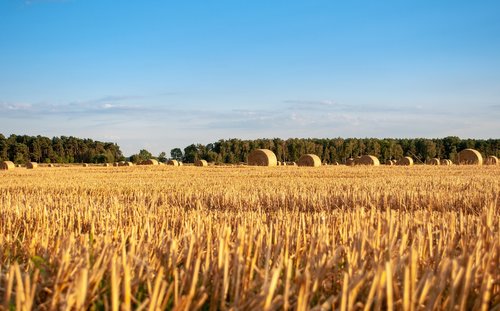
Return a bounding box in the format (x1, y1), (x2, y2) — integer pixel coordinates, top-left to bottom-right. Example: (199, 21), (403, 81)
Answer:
(0, 0), (500, 155)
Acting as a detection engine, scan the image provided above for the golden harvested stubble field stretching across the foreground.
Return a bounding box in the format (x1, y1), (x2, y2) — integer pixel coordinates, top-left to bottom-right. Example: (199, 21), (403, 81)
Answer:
(0, 165), (500, 310)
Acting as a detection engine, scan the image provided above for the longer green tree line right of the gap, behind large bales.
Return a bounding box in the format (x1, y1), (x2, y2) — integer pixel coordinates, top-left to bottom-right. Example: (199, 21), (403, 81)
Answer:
(170, 136), (500, 164)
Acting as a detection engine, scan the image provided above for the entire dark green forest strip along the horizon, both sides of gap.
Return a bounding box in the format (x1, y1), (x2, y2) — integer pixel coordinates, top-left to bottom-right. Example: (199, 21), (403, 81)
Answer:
(0, 134), (500, 164)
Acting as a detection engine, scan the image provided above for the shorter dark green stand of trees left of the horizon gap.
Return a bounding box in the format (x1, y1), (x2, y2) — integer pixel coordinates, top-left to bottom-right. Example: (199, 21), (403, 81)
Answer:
(0, 134), (125, 164)
